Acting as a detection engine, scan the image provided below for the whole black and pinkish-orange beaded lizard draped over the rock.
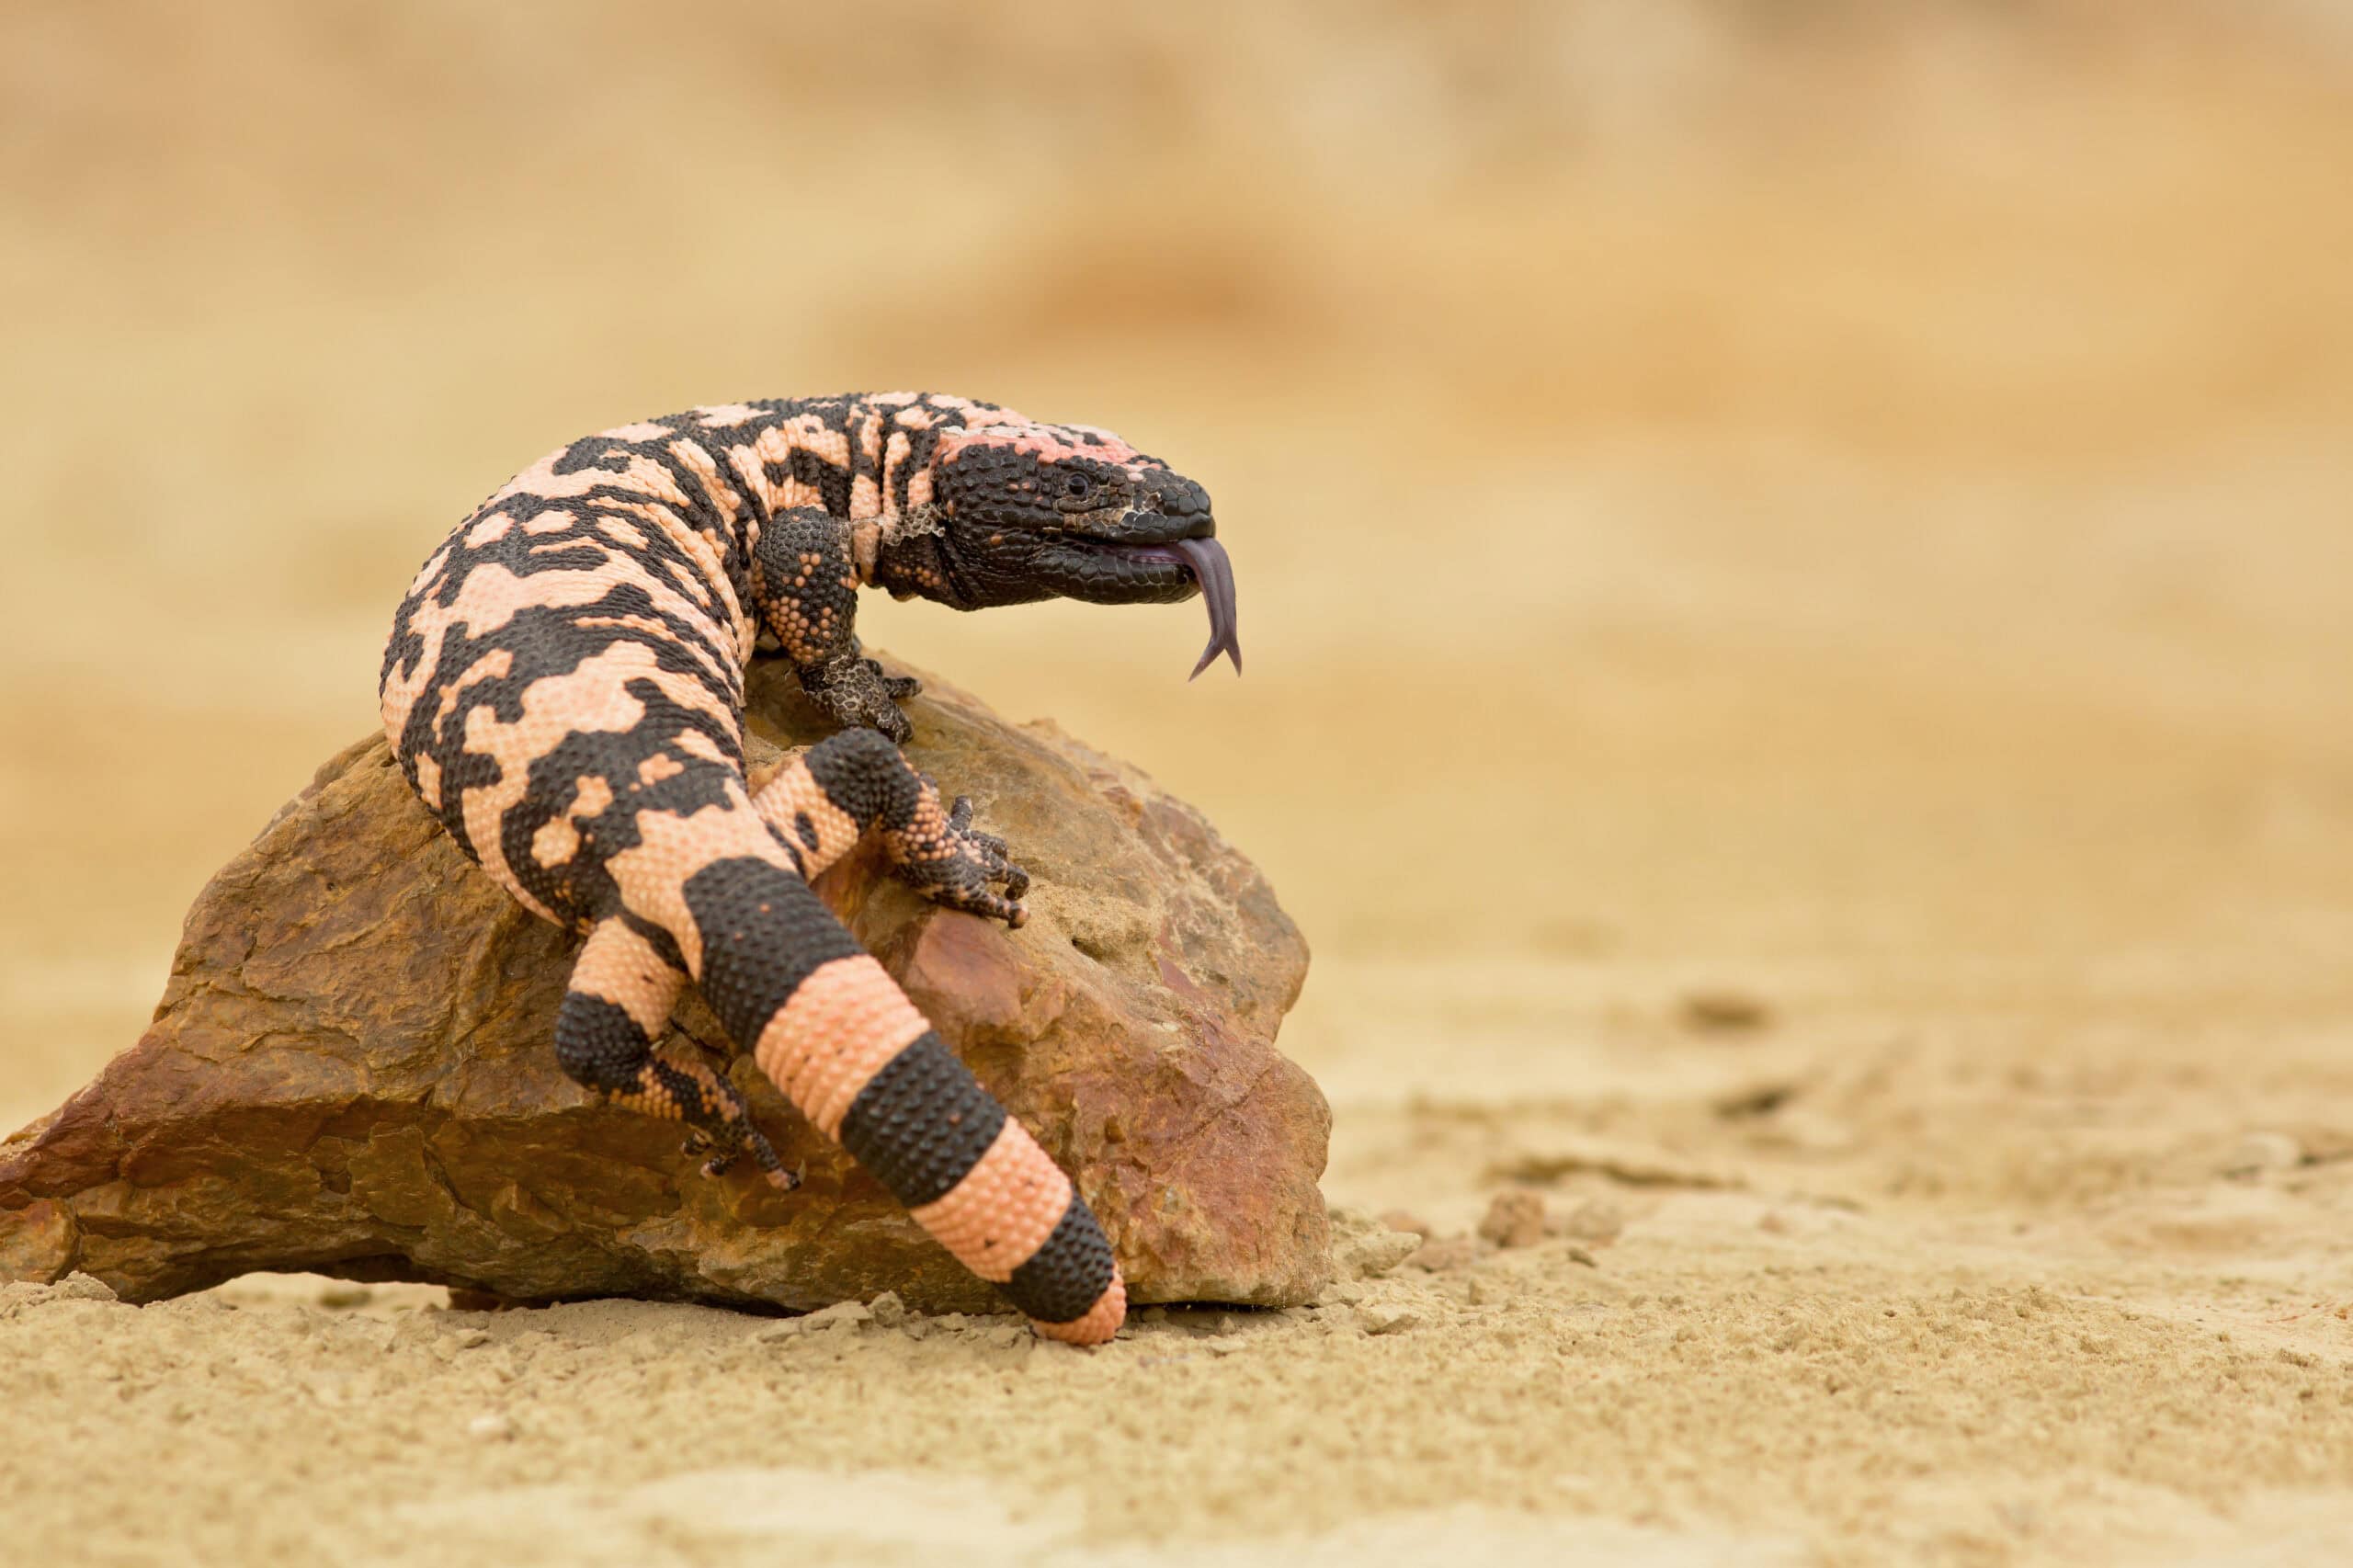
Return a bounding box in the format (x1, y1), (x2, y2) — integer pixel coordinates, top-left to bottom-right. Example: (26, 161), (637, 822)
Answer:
(379, 393), (1243, 1345)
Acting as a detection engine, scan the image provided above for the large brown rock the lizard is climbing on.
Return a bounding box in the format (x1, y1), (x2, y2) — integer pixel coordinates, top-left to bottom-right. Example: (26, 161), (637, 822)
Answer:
(0, 662), (1329, 1313)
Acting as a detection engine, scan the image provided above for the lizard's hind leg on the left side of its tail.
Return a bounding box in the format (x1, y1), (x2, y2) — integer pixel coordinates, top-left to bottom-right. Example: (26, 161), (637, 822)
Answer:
(555, 915), (800, 1189)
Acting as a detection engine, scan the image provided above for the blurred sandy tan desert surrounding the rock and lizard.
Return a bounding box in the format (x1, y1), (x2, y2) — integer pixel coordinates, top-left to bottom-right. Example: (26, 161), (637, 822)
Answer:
(0, 0), (2353, 1565)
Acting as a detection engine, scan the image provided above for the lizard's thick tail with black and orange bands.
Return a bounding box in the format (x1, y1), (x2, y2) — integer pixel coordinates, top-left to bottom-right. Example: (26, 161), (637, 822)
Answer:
(680, 857), (1127, 1345)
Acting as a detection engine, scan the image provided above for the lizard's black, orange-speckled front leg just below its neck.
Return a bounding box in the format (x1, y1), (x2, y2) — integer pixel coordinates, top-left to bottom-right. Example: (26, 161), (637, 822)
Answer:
(753, 506), (923, 742)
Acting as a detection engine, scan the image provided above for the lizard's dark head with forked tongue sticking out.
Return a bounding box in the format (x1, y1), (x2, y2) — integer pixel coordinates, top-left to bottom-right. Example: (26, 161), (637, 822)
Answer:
(882, 422), (1243, 676)
